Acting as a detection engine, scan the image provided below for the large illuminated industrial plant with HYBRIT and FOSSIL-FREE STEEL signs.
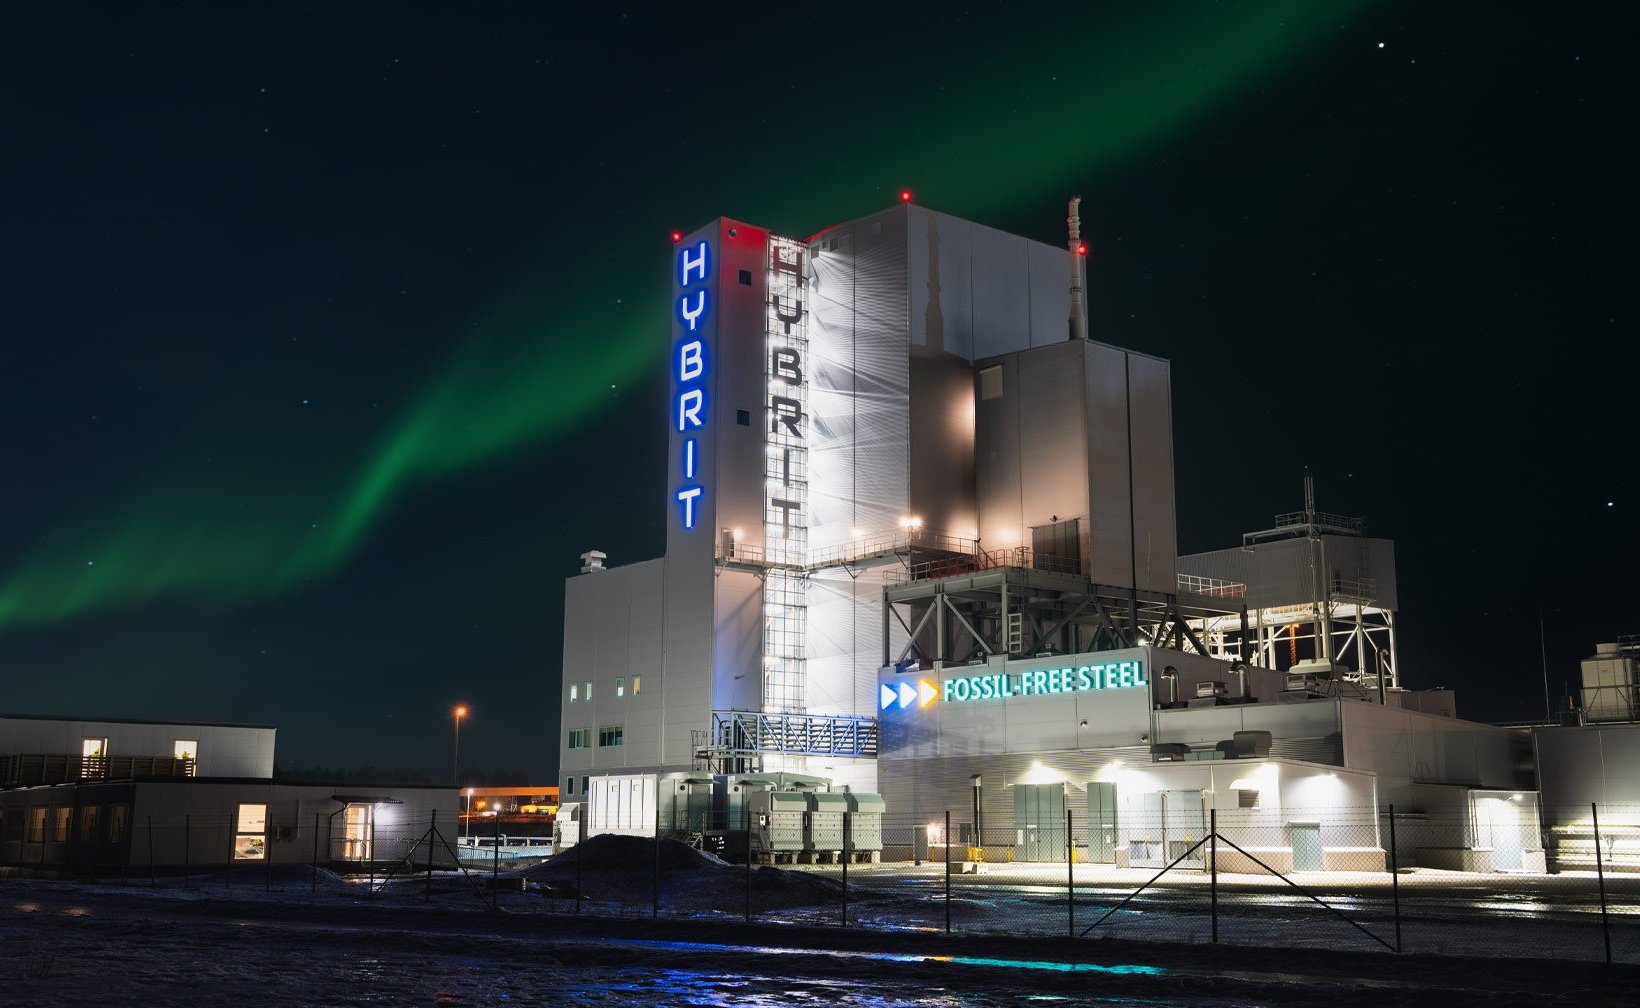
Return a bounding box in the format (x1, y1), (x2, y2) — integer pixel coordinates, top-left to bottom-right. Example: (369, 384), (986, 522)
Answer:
(559, 198), (1607, 870)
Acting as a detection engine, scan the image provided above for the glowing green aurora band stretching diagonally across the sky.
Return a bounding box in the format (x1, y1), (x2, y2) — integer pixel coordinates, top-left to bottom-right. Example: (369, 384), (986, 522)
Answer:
(0, 0), (1366, 629)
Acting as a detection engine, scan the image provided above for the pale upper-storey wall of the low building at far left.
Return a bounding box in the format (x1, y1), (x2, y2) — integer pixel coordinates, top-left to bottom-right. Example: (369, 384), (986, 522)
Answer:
(0, 718), (276, 777)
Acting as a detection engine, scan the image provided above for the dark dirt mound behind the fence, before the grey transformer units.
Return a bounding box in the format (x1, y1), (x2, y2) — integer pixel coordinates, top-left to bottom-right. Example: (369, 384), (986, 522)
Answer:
(513, 834), (843, 913)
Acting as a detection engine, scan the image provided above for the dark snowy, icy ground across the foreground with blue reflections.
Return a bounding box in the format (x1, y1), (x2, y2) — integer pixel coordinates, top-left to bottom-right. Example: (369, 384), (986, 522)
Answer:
(0, 858), (1640, 1008)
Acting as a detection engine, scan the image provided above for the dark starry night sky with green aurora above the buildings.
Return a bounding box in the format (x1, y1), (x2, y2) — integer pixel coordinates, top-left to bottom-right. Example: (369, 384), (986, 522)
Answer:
(0, 0), (1640, 782)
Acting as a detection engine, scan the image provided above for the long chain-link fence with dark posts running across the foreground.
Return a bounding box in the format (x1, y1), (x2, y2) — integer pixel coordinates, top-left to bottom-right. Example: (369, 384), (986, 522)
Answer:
(0, 793), (1640, 962)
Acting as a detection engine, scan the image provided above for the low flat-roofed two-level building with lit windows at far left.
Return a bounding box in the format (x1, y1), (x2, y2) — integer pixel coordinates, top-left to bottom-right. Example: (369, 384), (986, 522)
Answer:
(0, 715), (456, 874)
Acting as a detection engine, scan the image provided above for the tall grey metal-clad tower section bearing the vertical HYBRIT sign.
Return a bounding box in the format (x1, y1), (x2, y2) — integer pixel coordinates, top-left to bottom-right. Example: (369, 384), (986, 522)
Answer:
(559, 203), (1174, 800)
